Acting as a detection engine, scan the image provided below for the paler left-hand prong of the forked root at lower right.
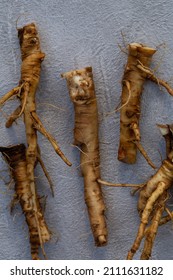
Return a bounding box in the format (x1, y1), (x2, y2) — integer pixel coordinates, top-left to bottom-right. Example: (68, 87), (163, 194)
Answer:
(127, 181), (169, 260)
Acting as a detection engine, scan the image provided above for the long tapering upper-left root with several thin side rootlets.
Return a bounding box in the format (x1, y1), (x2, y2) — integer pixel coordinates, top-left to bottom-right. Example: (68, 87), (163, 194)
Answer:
(0, 23), (71, 199)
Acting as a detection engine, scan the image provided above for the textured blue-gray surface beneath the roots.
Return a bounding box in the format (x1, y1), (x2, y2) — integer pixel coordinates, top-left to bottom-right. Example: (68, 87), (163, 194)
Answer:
(0, 0), (173, 259)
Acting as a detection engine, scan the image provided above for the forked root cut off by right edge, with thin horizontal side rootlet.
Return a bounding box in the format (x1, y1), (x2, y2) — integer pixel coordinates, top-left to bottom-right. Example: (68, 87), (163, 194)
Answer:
(98, 125), (173, 260)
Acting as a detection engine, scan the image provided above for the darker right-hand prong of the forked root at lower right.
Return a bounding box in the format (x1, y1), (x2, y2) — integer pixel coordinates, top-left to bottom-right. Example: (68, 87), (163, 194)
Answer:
(140, 191), (167, 260)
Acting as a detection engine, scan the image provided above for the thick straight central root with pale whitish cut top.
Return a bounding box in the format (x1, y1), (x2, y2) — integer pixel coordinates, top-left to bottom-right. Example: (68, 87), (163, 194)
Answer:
(62, 67), (107, 246)
